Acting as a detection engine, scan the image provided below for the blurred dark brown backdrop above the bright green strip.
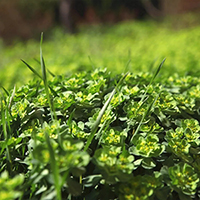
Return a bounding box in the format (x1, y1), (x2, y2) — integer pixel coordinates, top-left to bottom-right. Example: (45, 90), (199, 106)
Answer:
(0, 0), (200, 40)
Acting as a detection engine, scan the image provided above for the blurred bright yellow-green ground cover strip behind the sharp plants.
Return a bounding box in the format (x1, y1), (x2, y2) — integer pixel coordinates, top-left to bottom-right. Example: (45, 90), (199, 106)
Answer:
(0, 16), (200, 88)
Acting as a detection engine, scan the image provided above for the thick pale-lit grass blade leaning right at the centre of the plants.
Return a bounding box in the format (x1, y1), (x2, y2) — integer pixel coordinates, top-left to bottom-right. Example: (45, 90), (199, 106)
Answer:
(84, 73), (128, 151)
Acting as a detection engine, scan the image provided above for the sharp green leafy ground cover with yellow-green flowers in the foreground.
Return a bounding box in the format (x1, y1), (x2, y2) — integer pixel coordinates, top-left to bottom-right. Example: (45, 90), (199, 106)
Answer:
(0, 35), (200, 200)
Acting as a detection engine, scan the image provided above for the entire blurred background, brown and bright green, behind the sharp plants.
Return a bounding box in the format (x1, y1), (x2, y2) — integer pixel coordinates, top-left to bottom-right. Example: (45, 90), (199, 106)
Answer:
(0, 0), (200, 87)
